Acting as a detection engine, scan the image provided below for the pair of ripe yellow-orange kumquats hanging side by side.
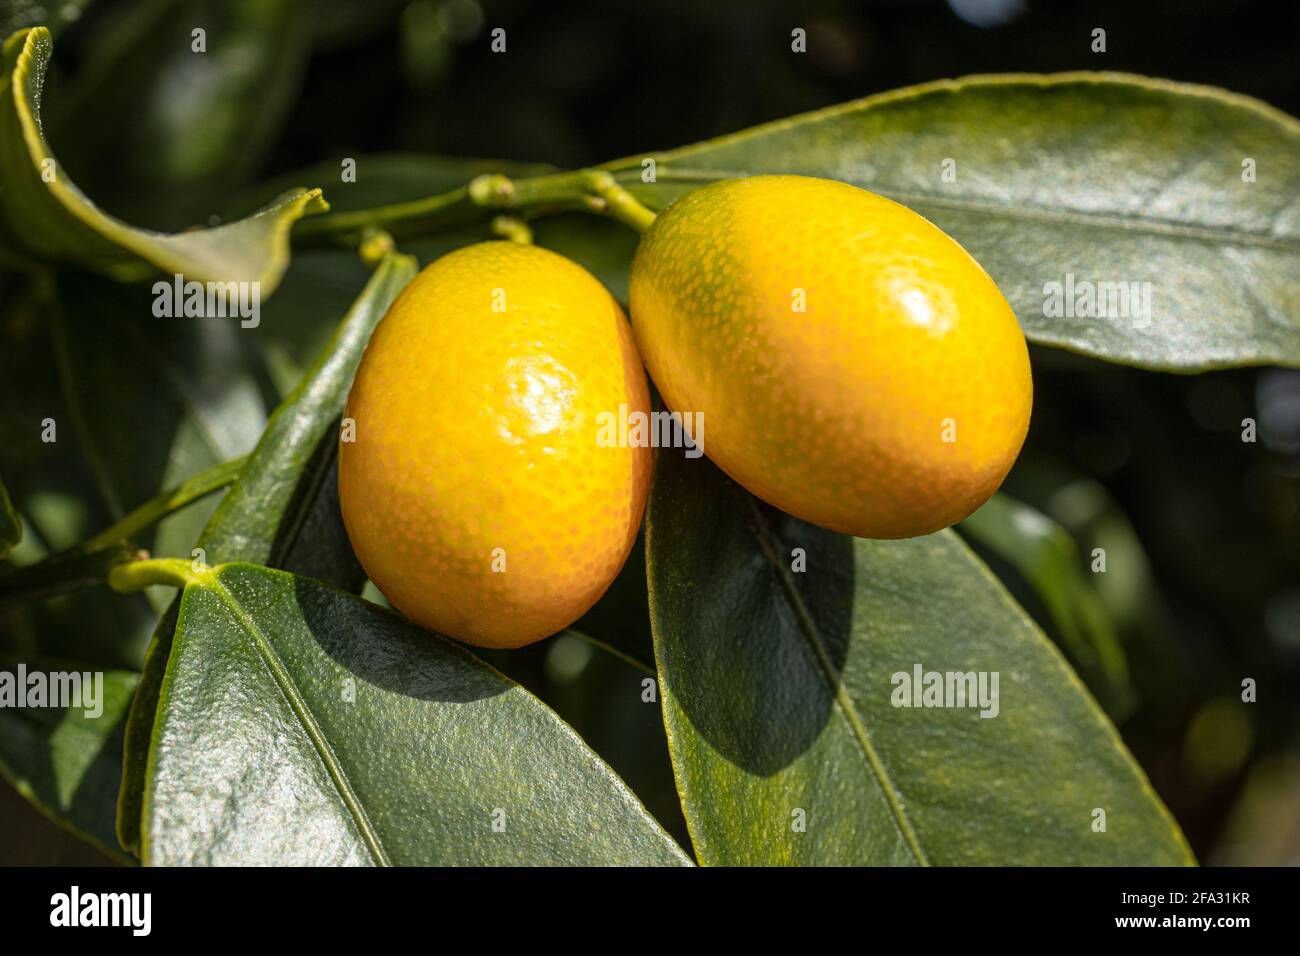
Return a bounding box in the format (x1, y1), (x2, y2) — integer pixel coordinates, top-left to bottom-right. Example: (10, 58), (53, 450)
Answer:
(339, 176), (1031, 646)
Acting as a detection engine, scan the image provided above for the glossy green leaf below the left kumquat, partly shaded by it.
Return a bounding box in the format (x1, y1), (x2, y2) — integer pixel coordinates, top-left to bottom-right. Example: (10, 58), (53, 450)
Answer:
(143, 564), (686, 865)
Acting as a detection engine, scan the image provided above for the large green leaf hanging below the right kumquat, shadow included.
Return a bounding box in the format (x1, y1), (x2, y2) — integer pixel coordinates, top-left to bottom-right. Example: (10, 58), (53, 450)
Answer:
(646, 454), (1193, 865)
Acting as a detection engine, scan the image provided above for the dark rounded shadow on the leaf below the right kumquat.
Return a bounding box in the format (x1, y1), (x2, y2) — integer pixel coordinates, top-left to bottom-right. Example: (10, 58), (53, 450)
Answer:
(647, 453), (854, 777)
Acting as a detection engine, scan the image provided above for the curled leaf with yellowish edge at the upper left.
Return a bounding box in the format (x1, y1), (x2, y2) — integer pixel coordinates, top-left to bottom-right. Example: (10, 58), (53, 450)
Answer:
(0, 27), (329, 286)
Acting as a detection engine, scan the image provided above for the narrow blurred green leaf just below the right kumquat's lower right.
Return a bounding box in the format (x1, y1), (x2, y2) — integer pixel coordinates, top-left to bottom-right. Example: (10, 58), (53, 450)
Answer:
(958, 494), (1134, 719)
